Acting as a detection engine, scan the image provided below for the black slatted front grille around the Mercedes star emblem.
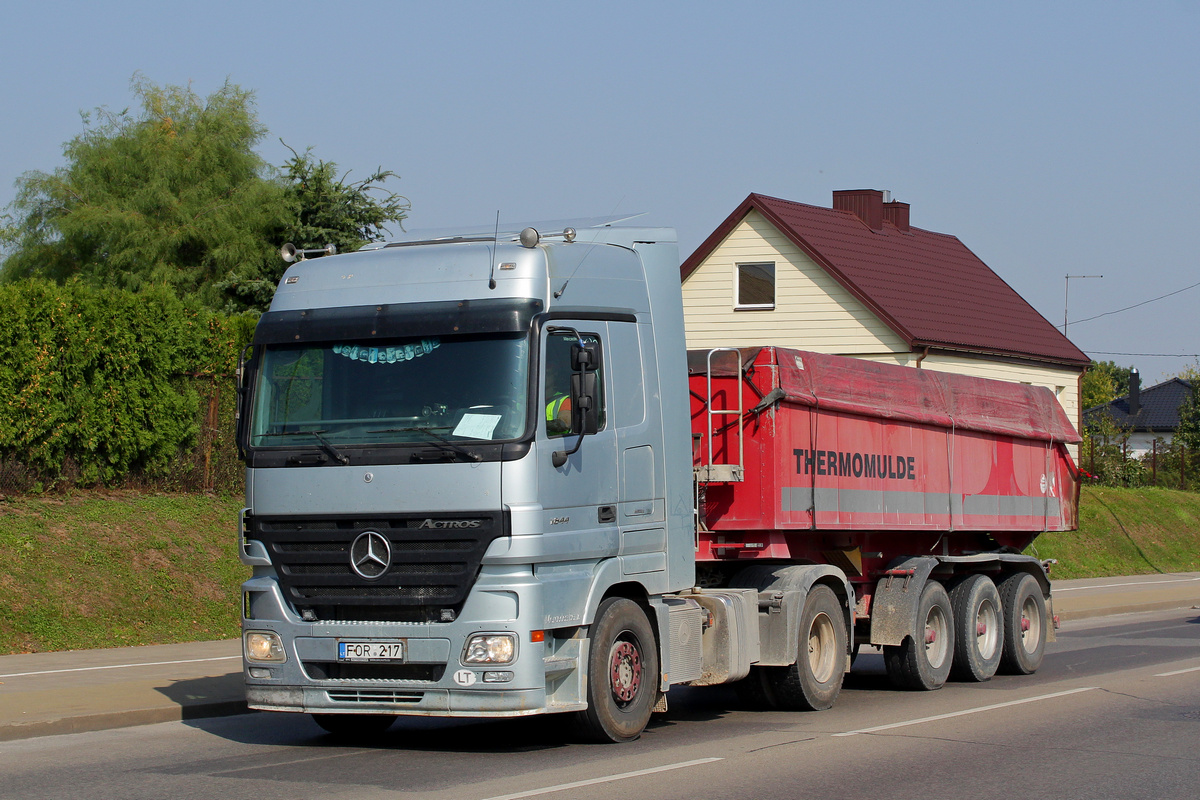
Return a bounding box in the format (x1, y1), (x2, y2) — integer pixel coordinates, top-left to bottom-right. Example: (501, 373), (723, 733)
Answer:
(248, 512), (506, 621)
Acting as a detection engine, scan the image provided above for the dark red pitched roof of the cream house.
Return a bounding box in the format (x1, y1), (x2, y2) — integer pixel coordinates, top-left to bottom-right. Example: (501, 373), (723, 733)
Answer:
(680, 194), (1090, 366)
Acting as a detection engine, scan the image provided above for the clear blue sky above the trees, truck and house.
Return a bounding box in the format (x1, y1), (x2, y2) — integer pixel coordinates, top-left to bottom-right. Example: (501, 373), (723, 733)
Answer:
(0, 0), (1200, 385)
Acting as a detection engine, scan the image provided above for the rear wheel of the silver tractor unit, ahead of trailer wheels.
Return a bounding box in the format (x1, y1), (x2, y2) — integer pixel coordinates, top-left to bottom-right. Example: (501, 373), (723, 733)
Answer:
(767, 585), (847, 711)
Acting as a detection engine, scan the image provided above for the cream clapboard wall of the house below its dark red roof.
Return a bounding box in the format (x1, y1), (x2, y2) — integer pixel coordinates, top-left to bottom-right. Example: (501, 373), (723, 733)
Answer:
(683, 210), (1080, 458)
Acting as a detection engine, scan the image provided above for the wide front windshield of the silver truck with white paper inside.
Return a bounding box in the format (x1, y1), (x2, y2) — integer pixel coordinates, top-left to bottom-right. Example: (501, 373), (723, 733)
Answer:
(250, 335), (529, 443)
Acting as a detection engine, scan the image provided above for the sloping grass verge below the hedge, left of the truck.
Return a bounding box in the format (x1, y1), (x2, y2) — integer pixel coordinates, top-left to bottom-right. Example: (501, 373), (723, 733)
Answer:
(0, 492), (250, 654)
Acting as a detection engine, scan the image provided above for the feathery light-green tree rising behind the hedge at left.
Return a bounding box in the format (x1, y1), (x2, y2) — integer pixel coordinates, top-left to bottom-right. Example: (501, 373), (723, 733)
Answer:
(4, 76), (292, 302)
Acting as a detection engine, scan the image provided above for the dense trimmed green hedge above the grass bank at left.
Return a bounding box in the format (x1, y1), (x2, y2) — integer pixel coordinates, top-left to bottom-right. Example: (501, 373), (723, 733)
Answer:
(0, 279), (253, 485)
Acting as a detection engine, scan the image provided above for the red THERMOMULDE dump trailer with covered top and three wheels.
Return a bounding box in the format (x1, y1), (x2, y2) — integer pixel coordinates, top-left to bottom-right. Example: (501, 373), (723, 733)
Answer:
(689, 347), (1079, 688)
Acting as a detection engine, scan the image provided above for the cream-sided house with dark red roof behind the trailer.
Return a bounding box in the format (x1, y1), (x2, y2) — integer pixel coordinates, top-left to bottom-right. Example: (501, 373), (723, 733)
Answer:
(680, 190), (1090, 448)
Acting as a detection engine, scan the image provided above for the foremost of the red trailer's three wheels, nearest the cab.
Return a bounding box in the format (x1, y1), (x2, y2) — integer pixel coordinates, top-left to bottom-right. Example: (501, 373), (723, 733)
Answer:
(883, 581), (954, 691)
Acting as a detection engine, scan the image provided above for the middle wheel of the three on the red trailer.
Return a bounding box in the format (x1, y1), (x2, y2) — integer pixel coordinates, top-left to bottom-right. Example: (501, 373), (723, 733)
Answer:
(950, 575), (1004, 681)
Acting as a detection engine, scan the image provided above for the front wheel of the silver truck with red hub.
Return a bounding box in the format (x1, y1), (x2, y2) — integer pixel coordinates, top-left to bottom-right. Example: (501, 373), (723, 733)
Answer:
(576, 597), (659, 742)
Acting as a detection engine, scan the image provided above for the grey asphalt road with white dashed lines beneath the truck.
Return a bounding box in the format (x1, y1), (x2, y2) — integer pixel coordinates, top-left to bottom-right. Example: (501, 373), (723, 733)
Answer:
(0, 609), (1200, 800)
